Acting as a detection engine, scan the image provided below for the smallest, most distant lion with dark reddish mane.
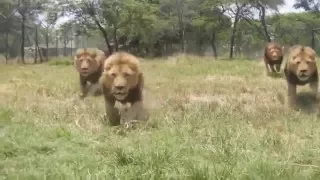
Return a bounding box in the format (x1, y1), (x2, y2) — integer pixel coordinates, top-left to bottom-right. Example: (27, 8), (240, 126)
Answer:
(264, 42), (283, 73)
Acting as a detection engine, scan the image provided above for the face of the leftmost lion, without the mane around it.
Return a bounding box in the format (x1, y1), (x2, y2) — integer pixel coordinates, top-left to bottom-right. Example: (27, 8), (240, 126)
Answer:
(74, 48), (100, 76)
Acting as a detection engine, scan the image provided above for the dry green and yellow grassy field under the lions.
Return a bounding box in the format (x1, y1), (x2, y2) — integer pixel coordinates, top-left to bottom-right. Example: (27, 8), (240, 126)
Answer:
(0, 57), (320, 180)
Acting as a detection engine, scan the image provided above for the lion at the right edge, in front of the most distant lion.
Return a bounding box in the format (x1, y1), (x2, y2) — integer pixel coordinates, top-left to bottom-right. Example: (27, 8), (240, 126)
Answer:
(284, 45), (319, 107)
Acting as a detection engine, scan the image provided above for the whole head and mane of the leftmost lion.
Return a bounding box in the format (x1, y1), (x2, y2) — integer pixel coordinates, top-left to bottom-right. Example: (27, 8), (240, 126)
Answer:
(74, 48), (105, 76)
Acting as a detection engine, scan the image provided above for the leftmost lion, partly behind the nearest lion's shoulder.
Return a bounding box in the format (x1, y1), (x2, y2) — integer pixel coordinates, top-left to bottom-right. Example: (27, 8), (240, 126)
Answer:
(74, 48), (107, 98)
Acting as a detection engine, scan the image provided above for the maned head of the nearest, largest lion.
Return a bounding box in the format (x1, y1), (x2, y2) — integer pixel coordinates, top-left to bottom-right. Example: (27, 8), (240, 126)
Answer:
(103, 52), (143, 101)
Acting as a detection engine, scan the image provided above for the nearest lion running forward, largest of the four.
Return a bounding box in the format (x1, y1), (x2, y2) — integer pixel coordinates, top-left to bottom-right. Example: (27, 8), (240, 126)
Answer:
(102, 52), (149, 126)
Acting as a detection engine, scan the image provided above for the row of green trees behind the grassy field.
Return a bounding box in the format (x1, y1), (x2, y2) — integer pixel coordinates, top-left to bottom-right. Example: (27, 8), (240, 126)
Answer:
(0, 0), (320, 60)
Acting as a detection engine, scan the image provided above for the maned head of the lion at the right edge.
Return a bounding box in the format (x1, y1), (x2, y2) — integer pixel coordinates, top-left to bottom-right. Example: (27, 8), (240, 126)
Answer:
(288, 45), (317, 81)
